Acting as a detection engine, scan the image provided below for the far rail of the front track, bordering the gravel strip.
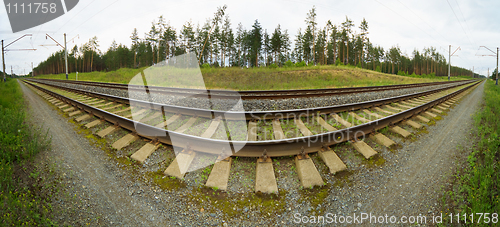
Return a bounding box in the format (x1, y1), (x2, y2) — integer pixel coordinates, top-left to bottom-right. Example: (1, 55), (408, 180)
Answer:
(26, 78), (474, 120)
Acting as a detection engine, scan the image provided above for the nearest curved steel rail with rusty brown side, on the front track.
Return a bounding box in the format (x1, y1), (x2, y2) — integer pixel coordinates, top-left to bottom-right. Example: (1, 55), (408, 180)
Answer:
(24, 81), (481, 157)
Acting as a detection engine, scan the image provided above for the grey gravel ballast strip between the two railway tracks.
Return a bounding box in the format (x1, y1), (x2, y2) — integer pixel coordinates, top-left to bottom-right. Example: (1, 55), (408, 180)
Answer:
(34, 81), (466, 111)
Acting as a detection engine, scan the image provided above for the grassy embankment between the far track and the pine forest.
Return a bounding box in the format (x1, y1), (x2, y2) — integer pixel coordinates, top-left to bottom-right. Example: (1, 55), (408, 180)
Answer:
(34, 66), (464, 90)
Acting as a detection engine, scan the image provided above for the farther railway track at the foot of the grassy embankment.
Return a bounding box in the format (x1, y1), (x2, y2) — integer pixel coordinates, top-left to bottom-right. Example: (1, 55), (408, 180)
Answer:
(30, 79), (468, 100)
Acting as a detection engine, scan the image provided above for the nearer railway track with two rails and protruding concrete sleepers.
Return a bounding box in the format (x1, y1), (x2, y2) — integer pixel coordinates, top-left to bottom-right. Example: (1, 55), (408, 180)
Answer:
(24, 81), (479, 192)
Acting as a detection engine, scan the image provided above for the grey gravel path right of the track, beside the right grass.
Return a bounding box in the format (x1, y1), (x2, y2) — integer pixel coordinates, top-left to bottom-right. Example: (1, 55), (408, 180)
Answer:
(324, 80), (484, 226)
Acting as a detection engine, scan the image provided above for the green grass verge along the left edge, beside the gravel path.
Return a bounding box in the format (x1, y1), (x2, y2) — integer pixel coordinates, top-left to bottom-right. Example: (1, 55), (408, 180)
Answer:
(0, 80), (54, 226)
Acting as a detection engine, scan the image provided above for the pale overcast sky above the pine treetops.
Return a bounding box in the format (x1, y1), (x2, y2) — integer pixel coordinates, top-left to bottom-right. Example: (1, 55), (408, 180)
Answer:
(0, 0), (500, 75)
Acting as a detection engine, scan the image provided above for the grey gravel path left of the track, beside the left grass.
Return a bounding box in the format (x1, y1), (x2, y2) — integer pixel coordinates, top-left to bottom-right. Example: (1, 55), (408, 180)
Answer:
(21, 80), (175, 226)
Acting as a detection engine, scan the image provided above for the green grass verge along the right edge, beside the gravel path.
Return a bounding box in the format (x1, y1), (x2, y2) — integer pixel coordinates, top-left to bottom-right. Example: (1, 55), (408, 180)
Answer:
(442, 80), (500, 226)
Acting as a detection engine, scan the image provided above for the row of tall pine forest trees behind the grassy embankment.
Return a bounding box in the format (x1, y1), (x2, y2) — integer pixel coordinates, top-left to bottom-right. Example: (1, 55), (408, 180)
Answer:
(34, 6), (472, 76)
